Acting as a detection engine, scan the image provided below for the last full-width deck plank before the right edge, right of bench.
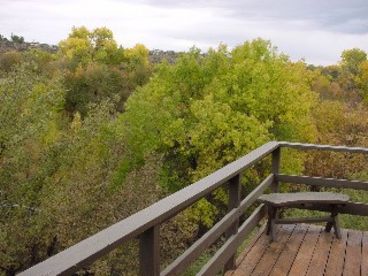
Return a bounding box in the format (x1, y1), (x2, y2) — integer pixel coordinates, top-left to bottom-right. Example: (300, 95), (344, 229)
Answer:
(343, 230), (363, 276)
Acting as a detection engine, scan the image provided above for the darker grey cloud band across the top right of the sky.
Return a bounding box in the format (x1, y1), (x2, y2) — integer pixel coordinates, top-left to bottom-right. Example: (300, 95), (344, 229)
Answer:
(140, 0), (368, 33)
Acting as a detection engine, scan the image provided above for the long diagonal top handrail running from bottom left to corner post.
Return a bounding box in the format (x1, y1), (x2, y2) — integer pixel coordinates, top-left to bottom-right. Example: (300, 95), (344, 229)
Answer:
(19, 141), (279, 275)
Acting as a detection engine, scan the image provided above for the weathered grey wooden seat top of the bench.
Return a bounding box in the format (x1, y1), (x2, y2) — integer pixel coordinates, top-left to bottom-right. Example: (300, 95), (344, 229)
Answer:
(258, 192), (349, 207)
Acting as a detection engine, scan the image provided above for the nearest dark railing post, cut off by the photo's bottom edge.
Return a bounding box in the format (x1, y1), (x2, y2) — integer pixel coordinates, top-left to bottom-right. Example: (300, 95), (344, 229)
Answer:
(139, 225), (160, 276)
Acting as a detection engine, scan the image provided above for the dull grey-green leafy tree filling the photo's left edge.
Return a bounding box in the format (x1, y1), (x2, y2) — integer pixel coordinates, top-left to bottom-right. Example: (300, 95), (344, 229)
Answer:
(0, 65), (64, 275)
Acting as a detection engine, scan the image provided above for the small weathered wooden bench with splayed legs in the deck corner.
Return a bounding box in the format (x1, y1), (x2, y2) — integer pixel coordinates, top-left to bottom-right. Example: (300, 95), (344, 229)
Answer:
(258, 192), (349, 241)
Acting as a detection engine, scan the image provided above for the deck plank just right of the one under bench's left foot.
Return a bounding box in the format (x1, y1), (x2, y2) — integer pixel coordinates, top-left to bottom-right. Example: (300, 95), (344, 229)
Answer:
(270, 224), (309, 276)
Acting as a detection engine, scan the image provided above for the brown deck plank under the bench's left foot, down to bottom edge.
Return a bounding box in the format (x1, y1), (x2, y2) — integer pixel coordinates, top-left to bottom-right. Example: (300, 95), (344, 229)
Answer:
(251, 225), (296, 276)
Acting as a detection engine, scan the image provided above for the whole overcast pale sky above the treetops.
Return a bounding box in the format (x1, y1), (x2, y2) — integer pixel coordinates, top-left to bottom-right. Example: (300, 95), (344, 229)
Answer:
(0, 0), (368, 65)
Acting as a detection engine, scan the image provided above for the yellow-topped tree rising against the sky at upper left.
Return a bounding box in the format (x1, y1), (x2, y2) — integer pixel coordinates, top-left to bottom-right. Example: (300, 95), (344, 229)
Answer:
(59, 27), (151, 116)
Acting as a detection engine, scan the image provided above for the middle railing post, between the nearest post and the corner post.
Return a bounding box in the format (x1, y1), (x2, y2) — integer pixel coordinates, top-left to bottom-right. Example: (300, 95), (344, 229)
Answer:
(224, 174), (241, 271)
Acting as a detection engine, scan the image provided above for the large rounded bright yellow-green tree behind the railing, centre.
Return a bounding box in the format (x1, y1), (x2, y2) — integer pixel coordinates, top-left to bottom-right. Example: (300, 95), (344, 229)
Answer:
(120, 39), (315, 225)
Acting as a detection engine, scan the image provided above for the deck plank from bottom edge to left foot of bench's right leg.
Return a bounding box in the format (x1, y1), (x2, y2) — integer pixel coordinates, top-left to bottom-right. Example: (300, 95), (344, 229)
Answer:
(307, 231), (334, 276)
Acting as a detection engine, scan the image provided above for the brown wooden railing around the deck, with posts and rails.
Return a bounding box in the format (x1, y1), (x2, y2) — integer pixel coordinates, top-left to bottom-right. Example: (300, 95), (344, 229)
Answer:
(20, 141), (368, 275)
